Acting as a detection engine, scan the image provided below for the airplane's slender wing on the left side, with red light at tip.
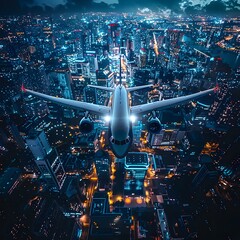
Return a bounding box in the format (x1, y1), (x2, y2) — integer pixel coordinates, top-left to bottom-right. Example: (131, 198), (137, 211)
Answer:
(22, 86), (110, 115)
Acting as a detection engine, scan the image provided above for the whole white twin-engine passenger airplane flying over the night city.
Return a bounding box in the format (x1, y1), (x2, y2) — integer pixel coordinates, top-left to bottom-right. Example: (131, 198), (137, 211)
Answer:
(22, 82), (218, 158)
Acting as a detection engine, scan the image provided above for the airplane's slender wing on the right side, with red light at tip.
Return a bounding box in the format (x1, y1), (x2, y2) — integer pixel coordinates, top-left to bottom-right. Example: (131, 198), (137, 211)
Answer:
(130, 88), (216, 114)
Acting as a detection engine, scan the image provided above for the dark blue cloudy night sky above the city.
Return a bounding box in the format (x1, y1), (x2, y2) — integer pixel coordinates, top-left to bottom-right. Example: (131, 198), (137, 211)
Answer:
(0, 0), (240, 15)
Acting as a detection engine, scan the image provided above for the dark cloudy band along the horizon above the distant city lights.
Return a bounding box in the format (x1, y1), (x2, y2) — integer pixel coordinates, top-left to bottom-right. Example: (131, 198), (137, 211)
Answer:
(0, 0), (240, 16)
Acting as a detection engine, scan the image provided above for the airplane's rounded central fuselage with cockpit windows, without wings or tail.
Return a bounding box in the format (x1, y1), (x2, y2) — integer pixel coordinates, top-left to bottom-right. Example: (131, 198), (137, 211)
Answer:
(109, 85), (132, 158)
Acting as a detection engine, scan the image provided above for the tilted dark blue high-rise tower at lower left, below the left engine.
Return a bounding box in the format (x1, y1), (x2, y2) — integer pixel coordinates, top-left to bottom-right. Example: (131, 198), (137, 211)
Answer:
(26, 131), (66, 190)
